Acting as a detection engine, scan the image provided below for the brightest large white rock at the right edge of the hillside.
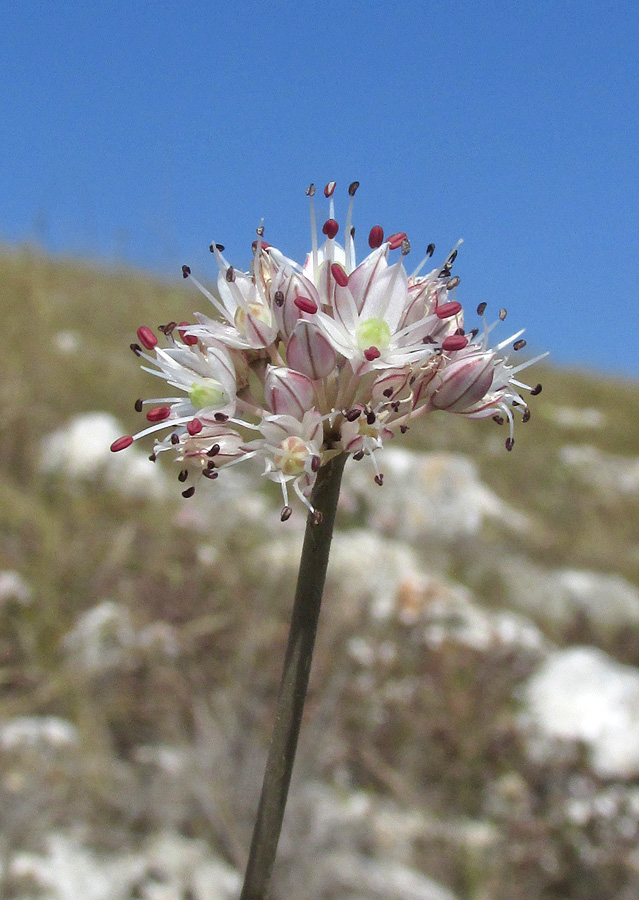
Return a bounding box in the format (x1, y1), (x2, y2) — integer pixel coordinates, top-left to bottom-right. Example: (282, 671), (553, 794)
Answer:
(521, 647), (639, 778)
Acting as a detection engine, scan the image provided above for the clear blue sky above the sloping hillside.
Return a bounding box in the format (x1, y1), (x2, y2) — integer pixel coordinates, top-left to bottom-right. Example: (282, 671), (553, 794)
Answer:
(0, 0), (639, 376)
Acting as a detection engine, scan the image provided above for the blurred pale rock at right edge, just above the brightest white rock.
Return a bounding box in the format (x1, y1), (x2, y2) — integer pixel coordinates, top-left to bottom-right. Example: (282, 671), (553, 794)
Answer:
(500, 559), (639, 634)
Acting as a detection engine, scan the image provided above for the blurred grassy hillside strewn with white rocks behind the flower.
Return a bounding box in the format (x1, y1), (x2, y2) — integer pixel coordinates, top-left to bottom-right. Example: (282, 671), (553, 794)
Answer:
(0, 250), (639, 900)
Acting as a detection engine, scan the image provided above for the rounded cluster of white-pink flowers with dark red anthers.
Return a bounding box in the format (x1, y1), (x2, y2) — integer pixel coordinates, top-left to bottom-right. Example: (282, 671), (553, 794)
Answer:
(111, 182), (545, 521)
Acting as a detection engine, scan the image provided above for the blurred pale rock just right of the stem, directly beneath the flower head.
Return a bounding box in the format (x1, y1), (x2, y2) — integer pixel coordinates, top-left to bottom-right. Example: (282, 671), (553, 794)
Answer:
(344, 447), (528, 543)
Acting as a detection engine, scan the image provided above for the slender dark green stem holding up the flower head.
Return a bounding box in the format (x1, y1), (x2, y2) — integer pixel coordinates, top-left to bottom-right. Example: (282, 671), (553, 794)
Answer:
(240, 453), (346, 900)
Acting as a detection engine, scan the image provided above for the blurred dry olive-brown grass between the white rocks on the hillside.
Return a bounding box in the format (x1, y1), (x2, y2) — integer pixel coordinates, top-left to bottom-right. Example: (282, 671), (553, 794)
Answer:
(0, 247), (639, 900)
